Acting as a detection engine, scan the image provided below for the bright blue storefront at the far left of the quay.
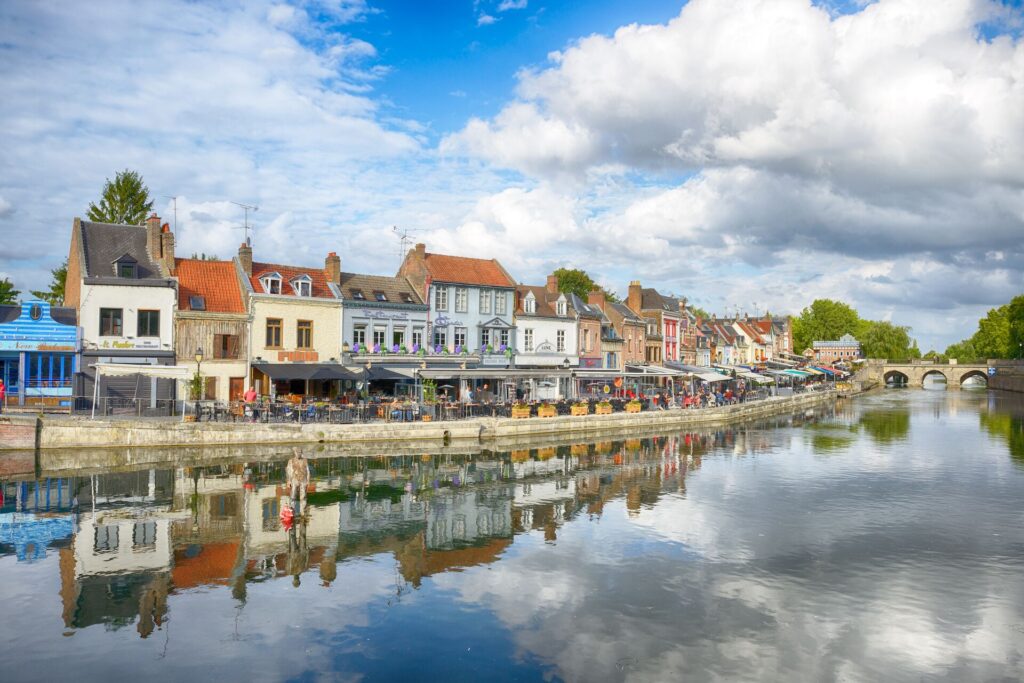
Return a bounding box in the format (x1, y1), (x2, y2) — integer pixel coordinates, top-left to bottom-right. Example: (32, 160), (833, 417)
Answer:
(0, 301), (82, 408)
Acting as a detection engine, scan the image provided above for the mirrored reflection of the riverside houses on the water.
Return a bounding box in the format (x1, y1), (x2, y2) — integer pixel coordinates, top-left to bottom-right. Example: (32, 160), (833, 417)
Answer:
(0, 431), (770, 637)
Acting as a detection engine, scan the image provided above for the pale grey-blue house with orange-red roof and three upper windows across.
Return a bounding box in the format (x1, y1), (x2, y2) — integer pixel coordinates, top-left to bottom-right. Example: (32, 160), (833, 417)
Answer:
(398, 244), (515, 367)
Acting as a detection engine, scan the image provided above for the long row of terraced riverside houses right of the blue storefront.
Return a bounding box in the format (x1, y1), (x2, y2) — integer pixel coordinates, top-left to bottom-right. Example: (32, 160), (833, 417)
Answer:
(36, 215), (793, 407)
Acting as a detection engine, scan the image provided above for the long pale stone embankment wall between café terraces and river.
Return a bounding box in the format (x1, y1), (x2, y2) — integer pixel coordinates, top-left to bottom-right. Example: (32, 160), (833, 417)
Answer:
(0, 391), (836, 452)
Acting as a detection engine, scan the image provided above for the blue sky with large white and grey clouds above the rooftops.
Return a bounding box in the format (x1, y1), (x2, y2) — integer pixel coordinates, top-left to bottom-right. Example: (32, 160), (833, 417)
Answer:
(0, 0), (1024, 350)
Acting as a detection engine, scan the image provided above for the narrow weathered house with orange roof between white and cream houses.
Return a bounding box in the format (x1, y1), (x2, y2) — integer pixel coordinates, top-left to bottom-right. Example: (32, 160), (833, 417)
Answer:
(174, 258), (249, 400)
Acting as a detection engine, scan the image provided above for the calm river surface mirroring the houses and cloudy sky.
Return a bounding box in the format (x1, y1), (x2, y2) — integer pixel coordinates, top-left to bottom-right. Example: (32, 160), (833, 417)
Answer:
(0, 390), (1024, 681)
